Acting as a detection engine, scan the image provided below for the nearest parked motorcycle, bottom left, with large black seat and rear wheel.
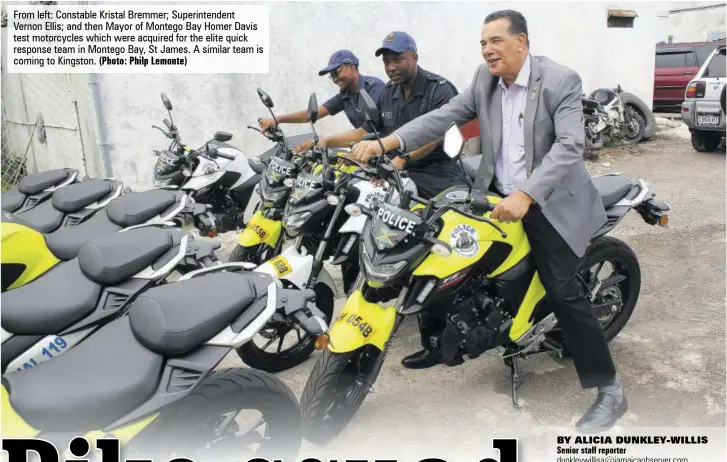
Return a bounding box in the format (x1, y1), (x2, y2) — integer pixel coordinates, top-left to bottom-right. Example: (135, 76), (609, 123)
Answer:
(0, 262), (326, 461)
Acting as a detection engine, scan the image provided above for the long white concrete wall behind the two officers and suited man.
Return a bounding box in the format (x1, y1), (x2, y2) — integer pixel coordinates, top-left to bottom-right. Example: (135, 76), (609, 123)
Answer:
(4, 1), (663, 188)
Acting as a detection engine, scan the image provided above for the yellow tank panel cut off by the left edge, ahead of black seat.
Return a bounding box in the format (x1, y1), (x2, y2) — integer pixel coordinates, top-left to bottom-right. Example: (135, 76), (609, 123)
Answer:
(2, 222), (60, 289)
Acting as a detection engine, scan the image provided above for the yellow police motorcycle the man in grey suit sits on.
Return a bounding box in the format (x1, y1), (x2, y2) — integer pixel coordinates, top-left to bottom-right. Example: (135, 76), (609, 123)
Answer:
(301, 91), (670, 443)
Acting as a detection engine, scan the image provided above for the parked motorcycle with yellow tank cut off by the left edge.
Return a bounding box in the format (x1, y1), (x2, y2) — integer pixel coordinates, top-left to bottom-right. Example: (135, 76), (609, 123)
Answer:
(0, 183), (207, 292)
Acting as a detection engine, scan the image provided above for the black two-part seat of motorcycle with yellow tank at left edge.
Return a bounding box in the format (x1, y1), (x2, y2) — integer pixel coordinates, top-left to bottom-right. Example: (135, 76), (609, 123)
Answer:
(46, 189), (183, 261)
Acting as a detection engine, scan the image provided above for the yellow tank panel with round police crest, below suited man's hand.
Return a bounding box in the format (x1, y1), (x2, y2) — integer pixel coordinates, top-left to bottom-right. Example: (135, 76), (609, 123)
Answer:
(414, 196), (530, 279)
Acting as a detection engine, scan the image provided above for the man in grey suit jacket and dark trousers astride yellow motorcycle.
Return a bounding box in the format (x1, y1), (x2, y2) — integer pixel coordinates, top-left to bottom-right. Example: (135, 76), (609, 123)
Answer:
(351, 10), (628, 430)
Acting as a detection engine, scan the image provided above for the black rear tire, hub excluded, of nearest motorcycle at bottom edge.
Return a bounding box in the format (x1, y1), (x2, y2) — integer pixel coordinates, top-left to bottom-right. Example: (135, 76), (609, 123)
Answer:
(123, 368), (303, 462)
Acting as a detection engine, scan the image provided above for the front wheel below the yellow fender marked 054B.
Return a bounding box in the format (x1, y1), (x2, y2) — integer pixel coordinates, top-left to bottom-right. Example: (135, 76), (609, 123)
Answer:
(300, 345), (384, 445)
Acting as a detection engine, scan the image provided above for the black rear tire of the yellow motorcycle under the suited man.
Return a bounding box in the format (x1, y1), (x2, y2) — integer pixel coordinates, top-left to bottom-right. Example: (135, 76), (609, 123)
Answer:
(547, 236), (641, 356)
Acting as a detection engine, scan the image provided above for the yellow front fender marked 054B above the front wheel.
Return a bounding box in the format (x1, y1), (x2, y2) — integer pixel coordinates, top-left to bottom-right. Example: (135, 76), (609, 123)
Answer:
(328, 290), (396, 353)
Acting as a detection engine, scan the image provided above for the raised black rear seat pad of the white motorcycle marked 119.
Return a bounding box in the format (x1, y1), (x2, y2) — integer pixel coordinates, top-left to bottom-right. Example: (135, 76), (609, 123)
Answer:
(78, 228), (176, 286)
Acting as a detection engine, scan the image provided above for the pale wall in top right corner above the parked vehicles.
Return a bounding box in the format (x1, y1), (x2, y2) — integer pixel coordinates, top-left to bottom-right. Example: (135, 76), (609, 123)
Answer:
(659, 2), (727, 43)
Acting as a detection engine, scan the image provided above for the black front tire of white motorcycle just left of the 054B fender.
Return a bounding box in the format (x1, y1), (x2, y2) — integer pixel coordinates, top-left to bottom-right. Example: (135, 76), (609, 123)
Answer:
(235, 283), (333, 373)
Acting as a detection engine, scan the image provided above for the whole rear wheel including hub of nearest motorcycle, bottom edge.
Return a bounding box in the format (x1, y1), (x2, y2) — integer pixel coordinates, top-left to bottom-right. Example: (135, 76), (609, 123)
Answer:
(123, 368), (303, 461)
